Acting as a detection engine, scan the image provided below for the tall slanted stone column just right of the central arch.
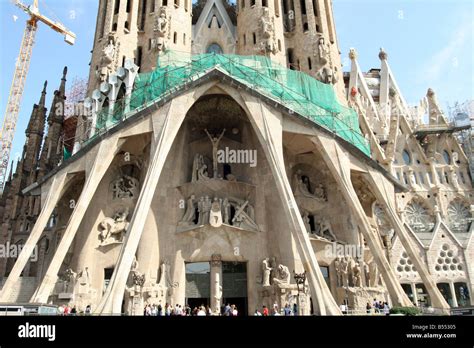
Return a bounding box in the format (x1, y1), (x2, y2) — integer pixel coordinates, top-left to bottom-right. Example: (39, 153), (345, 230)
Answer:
(243, 96), (341, 315)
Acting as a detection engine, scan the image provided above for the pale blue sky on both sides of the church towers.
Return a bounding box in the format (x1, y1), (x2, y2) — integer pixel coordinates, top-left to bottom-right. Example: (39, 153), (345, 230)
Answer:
(0, 0), (474, 174)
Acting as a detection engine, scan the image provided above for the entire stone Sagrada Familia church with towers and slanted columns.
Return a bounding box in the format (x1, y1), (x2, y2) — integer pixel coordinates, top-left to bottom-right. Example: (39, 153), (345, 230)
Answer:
(0, 0), (474, 315)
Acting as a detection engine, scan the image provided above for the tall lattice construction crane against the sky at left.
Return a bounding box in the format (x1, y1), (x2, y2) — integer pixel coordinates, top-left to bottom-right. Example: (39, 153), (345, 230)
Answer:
(0, 0), (76, 191)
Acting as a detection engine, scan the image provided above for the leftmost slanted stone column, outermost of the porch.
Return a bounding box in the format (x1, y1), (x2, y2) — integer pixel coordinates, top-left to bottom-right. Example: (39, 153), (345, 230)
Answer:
(0, 172), (67, 302)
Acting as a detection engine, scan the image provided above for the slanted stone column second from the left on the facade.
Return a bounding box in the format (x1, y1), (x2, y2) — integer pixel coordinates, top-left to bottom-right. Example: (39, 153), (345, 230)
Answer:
(30, 136), (118, 303)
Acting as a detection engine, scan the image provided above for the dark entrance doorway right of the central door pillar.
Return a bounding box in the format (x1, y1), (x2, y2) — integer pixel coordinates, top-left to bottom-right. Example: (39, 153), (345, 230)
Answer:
(222, 262), (248, 316)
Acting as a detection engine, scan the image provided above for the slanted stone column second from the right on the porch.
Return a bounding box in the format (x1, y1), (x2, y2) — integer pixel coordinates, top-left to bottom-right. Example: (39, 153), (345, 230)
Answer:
(311, 135), (413, 306)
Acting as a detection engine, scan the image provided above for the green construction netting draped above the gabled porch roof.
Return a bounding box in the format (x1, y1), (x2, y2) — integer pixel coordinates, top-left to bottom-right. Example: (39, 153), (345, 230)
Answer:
(96, 51), (370, 156)
